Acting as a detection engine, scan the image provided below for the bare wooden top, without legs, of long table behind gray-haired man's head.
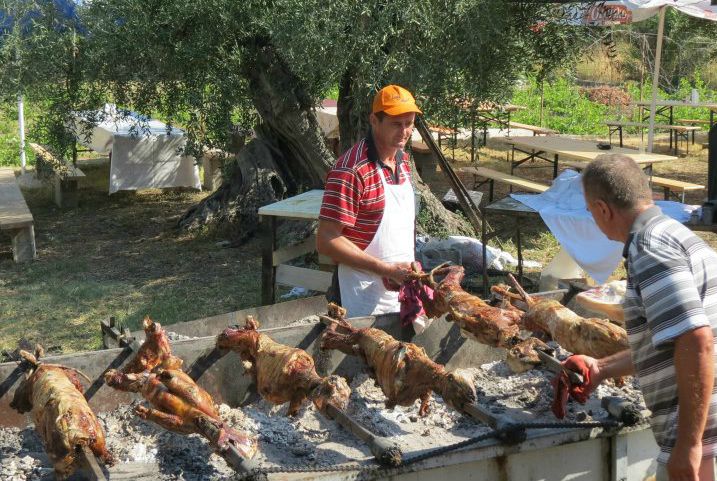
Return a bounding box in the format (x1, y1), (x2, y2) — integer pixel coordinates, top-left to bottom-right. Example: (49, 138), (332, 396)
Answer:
(504, 135), (678, 164)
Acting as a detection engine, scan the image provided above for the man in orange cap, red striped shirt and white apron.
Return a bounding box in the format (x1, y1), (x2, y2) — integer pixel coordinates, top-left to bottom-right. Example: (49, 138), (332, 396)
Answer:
(316, 85), (421, 317)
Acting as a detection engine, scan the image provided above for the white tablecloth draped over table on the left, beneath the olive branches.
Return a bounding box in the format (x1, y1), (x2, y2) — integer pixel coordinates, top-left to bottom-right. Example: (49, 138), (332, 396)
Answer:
(74, 105), (201, 194)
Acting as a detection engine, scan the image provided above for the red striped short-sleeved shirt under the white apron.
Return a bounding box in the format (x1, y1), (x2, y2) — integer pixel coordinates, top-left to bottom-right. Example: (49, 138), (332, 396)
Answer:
(319, 133), (410, 249)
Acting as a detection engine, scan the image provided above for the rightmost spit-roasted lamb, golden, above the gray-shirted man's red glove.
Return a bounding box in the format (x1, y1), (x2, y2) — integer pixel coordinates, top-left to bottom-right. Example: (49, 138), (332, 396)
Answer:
(492, 276), (628, 358)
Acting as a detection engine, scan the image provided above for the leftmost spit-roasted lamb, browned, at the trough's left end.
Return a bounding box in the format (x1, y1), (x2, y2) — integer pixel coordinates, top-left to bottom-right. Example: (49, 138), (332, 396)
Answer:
(10, 349), (113, 479)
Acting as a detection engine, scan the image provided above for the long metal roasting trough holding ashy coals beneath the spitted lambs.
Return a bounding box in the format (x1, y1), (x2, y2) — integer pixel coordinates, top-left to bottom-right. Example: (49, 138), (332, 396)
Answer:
(0, 290), (657, 481)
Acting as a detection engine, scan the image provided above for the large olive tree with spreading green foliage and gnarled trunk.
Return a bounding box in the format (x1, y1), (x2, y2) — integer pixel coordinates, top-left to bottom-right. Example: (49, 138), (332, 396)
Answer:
(1, 0), (578, 238)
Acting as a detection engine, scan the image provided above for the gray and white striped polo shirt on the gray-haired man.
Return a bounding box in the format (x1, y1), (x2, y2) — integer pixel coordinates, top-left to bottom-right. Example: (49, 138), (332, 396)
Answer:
(623, 206), (717, 463)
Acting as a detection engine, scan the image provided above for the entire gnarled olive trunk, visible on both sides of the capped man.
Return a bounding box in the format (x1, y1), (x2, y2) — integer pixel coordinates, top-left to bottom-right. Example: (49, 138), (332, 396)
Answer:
(179, 41), (472, 242)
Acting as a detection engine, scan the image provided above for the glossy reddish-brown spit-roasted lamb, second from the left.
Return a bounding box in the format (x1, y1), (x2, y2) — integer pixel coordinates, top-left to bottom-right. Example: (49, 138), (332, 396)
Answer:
(104, 318), (257, 459)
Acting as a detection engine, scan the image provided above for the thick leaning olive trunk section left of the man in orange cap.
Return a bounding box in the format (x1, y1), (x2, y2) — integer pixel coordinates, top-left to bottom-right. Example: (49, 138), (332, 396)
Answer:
(179, 39), (334, 238)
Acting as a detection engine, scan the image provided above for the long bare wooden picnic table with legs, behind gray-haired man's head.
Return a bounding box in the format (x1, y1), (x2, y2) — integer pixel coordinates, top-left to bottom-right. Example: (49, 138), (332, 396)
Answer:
(505, 136), (677, 178)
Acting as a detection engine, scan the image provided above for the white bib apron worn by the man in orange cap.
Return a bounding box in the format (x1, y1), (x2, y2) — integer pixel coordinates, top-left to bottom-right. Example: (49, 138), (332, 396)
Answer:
(338, 166), (416, 317)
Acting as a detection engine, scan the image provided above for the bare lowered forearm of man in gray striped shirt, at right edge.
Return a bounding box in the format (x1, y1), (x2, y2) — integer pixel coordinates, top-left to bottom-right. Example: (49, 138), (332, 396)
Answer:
(675, 326), (714, 446)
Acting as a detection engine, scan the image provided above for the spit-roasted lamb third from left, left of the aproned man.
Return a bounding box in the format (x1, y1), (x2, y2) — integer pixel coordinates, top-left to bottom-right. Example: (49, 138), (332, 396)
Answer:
(217, 316), (351, 416)
